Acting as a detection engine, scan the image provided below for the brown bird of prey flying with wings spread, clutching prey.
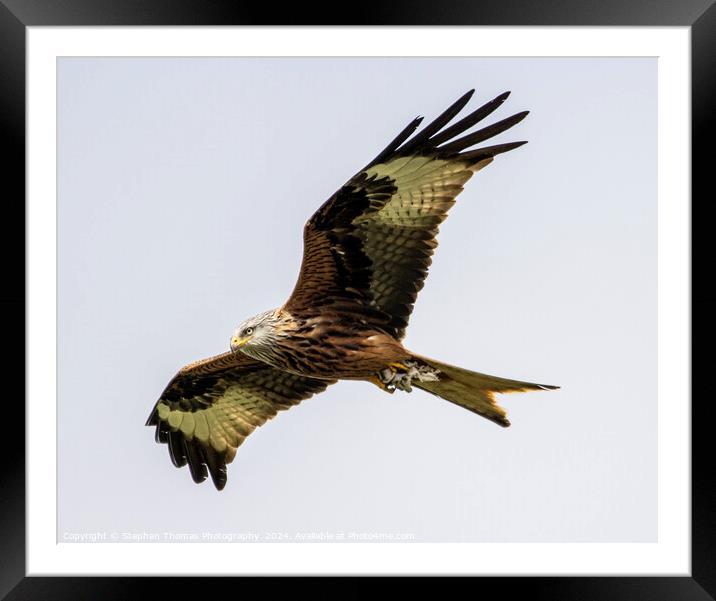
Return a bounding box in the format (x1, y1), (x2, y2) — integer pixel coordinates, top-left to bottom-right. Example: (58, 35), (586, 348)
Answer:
(146, 90), (558, 490)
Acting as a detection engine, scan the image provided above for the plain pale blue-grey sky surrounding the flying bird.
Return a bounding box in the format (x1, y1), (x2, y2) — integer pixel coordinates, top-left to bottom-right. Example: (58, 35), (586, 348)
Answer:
(58, 58), (657, 542)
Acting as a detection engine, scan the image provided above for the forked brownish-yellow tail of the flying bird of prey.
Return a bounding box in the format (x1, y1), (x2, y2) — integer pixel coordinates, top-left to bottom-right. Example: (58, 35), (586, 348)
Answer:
(411, 355), (559, 427)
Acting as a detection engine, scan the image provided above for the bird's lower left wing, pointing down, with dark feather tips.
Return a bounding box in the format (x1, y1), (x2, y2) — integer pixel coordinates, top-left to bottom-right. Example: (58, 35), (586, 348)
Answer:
(146, 353), (335, 490)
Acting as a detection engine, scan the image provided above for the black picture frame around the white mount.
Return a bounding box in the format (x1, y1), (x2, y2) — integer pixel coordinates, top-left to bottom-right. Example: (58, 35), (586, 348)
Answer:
(0, 0), (716, 601)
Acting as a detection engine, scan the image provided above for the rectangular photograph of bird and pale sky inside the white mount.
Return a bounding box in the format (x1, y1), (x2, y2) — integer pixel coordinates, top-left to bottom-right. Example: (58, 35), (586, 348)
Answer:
(57, 57), (658, 544)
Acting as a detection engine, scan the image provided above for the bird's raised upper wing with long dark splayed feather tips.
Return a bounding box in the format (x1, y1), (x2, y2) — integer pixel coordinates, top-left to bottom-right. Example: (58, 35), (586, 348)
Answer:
(285, 90), (527, 339)
